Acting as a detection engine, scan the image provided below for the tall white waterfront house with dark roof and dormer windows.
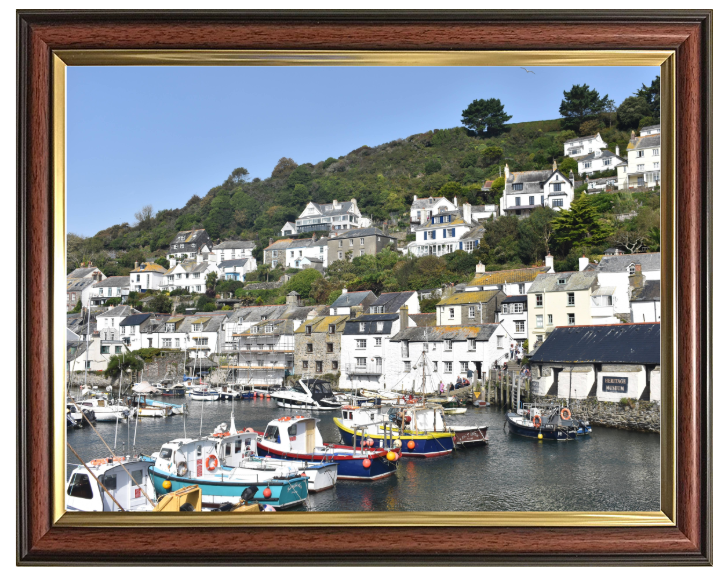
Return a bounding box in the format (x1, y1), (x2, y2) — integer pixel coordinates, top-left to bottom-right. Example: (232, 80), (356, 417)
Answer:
(339, 307), (415, 390)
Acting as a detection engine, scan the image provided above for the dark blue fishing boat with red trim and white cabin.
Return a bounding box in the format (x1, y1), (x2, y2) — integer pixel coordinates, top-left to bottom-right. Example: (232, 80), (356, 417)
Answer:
(257, 416), (398, 480)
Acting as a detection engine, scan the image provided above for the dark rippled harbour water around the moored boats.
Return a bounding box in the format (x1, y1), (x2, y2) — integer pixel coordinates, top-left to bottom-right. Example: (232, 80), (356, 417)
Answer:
(67, 398), (660, 512)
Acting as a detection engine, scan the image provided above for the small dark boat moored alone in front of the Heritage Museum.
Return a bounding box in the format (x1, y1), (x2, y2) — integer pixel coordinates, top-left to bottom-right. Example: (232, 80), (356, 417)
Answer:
(505, 403), (592, 440)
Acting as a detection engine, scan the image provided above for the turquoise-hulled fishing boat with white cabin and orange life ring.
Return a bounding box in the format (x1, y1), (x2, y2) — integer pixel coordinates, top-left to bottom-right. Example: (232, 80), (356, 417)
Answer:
(150, 434), (308, 509)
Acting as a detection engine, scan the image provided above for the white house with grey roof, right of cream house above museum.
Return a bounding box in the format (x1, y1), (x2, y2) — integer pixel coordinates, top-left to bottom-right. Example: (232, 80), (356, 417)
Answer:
(592, 252), (660, 320)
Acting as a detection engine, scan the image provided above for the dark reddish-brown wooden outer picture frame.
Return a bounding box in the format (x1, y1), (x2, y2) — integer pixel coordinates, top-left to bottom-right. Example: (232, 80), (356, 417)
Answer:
(17, 10), (712, 565)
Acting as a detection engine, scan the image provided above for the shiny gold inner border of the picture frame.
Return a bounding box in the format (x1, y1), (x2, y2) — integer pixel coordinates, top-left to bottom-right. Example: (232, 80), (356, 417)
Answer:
(50, 50), (678, 528)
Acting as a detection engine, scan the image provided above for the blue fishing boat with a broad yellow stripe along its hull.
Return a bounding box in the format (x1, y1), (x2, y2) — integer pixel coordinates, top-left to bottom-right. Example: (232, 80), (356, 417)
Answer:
(333, 399), (455, 458)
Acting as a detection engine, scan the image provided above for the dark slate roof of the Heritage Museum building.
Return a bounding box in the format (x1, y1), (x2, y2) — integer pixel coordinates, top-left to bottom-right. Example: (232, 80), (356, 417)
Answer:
(531, 322), (660, 364)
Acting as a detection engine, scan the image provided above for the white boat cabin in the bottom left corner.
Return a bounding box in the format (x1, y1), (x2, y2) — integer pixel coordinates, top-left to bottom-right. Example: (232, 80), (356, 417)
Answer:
(65, 457), (155, 512)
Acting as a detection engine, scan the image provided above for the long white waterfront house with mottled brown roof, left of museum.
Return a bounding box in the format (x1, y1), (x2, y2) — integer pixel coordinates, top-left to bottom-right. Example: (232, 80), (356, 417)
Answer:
(385, 324), (512, 392)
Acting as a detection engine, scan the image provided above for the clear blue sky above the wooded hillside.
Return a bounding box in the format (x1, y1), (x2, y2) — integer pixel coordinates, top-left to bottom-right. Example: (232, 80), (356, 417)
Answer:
(67, 67), (659, 236)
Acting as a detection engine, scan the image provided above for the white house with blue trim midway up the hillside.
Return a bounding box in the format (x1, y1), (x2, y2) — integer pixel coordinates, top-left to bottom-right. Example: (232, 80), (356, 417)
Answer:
(408, 204), (484, 256)
